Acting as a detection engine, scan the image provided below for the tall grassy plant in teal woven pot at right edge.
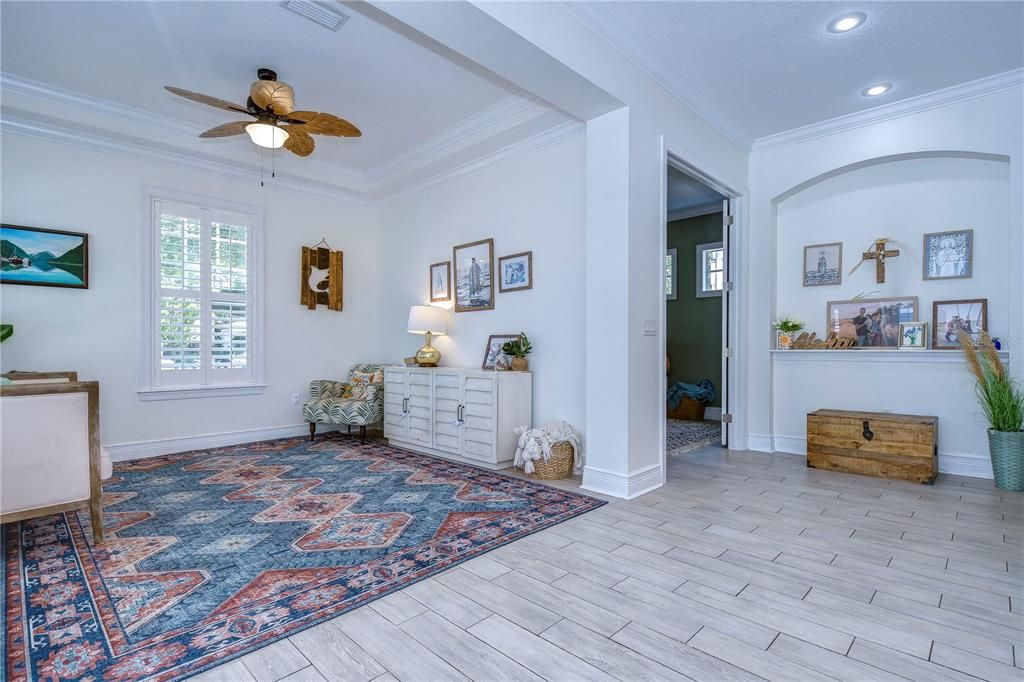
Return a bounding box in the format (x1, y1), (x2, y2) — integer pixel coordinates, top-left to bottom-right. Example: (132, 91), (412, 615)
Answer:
(956, 331), (1024, 491)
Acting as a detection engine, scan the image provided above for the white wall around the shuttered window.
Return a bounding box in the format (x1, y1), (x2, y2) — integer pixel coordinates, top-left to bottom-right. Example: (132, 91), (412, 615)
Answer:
(0, 134), (382, 454)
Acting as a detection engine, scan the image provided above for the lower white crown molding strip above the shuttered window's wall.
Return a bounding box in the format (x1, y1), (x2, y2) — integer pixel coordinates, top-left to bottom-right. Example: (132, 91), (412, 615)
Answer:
(0, 109), (374, 206)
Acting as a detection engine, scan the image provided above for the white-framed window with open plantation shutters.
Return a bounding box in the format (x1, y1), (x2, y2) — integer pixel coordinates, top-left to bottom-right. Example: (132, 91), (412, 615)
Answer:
(140, 187), (262, 399)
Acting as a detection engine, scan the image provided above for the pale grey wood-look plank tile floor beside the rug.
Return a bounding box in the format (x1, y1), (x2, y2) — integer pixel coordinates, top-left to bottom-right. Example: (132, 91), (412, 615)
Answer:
(195, 446), (1024, 682)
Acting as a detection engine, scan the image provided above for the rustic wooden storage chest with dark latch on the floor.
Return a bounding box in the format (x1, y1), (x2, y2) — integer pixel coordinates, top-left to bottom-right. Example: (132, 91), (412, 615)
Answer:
(807, 410), (939, 483)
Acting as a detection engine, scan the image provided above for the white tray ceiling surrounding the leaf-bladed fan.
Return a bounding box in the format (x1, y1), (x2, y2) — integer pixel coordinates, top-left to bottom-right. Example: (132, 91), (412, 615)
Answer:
(0, 2), (567, 176)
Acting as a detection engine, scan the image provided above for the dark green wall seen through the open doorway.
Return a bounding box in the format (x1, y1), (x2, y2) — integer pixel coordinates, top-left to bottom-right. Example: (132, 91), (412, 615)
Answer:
(666, 213), (722, 408)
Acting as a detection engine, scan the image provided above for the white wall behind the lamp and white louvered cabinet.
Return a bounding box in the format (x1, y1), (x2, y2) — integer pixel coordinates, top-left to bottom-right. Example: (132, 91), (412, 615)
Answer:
(378, 135), (589, 433)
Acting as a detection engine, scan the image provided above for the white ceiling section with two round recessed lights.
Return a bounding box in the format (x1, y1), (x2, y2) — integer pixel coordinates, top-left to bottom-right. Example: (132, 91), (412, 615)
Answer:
(566, 0), (1024, 146)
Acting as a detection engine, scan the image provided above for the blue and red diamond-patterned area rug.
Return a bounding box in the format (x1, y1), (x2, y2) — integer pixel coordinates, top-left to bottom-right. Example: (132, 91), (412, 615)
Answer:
(0, 436), (603, 682)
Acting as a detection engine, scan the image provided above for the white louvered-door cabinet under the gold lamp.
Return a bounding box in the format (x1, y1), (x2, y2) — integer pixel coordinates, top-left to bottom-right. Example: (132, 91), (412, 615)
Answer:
(384, 367), (534, 469)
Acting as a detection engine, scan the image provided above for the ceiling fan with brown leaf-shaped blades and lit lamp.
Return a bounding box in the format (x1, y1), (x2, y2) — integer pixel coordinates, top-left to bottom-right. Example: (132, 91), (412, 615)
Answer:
(164, 69), (362, 157)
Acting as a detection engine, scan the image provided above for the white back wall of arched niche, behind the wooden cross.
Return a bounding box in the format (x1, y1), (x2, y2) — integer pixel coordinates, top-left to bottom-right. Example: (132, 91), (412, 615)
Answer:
(775, 158), (1011, 337)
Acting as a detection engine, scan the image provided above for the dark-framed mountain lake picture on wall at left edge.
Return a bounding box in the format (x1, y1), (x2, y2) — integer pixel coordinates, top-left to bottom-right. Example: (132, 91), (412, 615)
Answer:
(0, 223), (89, 289)
